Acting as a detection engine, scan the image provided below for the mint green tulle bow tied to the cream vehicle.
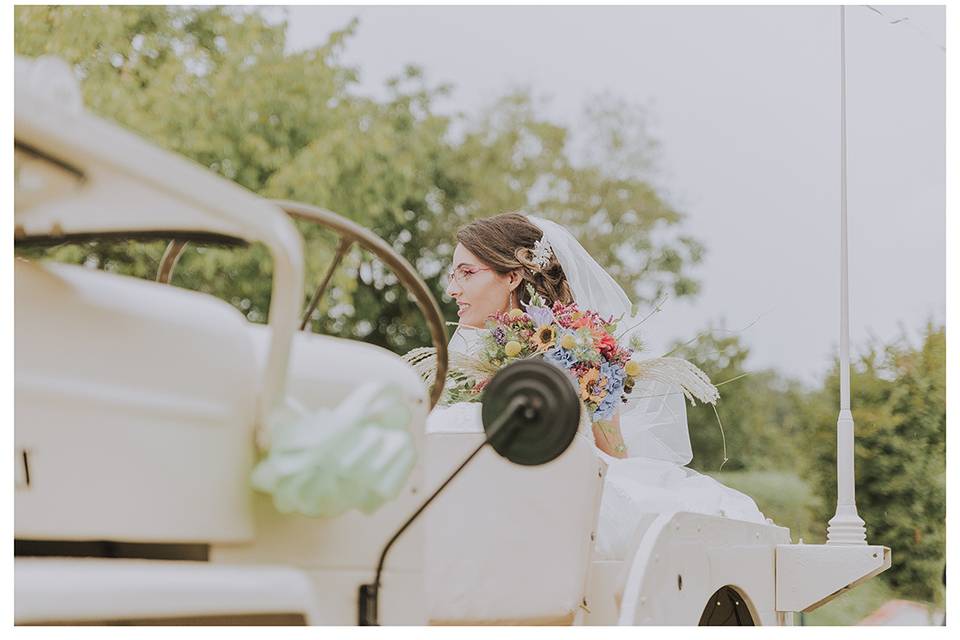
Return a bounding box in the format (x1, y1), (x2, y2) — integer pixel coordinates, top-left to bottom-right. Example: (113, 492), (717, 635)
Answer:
(251, 383), (416, 517)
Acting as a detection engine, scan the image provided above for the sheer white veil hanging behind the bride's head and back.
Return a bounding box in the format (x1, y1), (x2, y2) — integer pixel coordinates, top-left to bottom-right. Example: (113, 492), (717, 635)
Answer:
(527, 216), (693, 465)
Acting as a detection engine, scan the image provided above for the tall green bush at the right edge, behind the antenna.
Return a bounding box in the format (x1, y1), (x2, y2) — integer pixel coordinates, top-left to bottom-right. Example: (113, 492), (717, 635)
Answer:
(804, 324), (946, 600)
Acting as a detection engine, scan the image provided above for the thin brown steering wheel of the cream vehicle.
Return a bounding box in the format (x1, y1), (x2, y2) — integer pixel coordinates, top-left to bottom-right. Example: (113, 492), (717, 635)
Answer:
(157, 200), (449, 409)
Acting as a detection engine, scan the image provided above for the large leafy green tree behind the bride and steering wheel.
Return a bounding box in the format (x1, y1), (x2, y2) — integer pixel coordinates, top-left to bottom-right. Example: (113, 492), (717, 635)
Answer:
(14, 6), (703, 351)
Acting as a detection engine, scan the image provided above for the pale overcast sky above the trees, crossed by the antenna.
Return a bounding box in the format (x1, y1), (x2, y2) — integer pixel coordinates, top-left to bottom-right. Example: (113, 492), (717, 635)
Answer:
(270, 6), (946, 384)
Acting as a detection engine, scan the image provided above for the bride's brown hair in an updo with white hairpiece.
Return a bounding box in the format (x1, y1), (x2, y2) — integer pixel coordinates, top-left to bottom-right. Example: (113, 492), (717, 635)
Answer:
(457, 213), (573, 305)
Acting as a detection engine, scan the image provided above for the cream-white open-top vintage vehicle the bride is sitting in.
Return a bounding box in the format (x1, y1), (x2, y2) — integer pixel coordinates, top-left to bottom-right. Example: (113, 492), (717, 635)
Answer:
(14, 59), (890, 625)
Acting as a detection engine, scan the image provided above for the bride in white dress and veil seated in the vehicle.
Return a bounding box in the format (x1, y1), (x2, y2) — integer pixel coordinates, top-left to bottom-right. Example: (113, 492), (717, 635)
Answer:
(427, 213), (765, 558)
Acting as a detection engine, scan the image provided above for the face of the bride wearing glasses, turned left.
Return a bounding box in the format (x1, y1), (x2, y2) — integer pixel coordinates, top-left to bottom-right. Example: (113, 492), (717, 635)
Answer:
(447, 243), (521, 327)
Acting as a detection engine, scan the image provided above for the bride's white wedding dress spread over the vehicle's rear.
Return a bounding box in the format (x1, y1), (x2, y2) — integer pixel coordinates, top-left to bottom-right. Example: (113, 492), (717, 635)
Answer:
(426, 327), (765, 560)
